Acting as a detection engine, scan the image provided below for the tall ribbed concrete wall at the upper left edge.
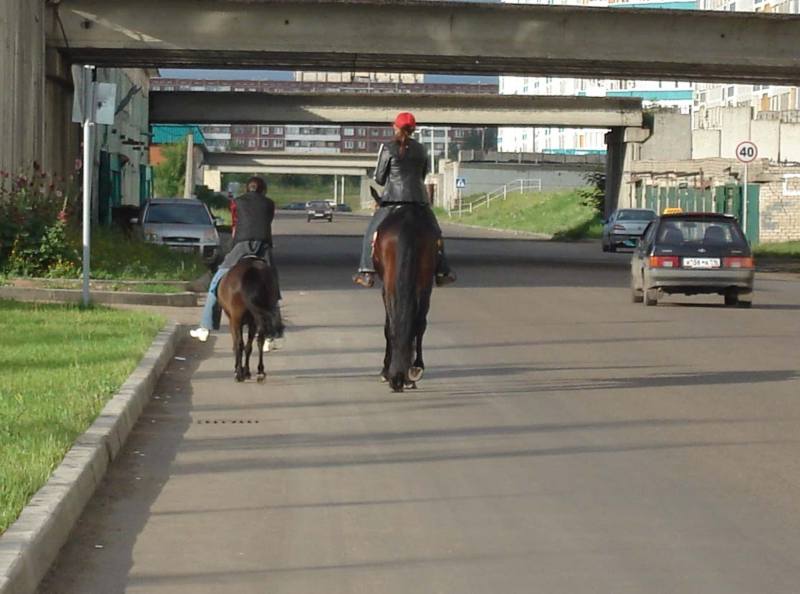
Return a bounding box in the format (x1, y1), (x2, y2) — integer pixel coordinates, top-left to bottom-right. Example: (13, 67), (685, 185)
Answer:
(0, 0), (46, 172)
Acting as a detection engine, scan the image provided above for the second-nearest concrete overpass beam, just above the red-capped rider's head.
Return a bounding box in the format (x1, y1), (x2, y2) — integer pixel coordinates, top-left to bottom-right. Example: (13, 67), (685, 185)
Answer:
(150, 91), (642, 128)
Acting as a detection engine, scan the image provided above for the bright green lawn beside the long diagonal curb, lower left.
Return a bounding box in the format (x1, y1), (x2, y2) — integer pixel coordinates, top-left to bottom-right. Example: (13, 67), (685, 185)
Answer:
(0, 300), (164, 533)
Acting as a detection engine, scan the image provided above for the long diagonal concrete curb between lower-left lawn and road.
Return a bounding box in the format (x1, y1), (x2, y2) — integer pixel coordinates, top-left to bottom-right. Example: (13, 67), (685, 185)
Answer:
(0, 322), (182, 594)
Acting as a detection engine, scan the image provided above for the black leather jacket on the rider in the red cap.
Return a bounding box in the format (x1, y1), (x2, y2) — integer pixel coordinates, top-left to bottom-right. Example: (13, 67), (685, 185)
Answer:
(374, 138), (430, 204)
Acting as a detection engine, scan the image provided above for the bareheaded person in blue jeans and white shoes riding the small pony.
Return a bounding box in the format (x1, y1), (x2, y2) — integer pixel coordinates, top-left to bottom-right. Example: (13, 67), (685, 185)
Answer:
(189, 176), (283, 342)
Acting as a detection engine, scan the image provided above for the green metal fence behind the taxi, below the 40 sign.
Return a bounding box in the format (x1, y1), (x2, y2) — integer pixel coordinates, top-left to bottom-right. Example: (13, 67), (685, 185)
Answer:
(635, 184), (760, 243)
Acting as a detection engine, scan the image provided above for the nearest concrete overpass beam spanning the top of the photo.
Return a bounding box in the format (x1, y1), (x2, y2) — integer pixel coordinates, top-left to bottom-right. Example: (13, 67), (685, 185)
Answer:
(48, 0), (800, 84)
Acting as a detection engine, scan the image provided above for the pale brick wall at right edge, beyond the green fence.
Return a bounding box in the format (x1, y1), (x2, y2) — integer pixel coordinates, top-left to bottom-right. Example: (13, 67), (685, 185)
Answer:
(759, 167), (800, 243)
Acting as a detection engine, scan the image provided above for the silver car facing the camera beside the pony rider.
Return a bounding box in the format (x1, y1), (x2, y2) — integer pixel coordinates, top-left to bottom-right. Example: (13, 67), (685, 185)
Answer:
(131, 198), (222, 264)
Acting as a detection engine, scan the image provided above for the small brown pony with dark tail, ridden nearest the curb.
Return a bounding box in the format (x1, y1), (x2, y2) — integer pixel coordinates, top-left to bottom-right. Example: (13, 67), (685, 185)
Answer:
(217, 258), (283, 383)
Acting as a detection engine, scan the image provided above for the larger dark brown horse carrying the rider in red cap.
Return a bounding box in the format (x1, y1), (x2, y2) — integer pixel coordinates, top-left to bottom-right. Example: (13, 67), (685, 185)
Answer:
(372, 204), (438, 392)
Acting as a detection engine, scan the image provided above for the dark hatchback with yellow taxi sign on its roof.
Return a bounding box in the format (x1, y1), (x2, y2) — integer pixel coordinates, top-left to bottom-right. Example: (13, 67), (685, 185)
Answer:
(631, 213), (755, 307)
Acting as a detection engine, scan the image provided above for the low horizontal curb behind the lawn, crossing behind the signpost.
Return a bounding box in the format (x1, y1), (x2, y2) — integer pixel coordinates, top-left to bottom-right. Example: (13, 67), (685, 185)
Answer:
(0, 286), (197, 307)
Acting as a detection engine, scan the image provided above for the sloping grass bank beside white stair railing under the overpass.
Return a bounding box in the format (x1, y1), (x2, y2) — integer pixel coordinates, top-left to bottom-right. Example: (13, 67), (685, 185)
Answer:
(445, 191), (602, 239)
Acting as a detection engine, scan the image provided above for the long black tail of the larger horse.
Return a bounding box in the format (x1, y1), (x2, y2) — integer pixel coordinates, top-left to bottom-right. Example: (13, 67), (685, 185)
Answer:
(386, 220), (420, 390)
